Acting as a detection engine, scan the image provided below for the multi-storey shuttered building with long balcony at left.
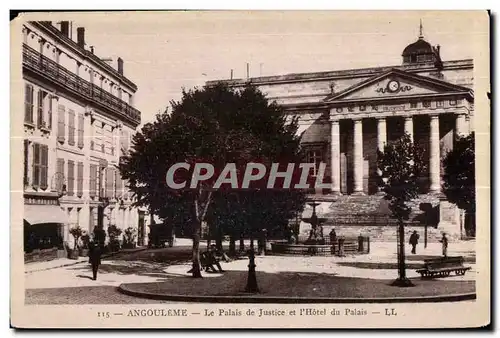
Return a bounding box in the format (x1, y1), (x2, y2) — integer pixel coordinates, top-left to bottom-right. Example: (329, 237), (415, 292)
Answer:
(22, 21), (145, 254)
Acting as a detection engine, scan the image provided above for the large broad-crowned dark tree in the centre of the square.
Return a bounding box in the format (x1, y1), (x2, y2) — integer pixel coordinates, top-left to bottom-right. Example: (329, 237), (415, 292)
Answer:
(120, 83), (301, 277)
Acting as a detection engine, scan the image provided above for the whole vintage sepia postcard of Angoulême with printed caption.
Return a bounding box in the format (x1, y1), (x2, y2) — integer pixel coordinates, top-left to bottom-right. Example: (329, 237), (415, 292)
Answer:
(10, 11), (491, 328)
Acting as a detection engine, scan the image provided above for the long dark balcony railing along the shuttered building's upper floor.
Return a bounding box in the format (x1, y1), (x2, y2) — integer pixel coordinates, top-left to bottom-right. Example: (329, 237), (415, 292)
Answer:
(23, 45), (141, 123)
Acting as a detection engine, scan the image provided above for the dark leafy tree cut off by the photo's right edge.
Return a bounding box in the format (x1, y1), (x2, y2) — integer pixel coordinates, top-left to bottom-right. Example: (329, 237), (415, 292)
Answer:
(443, 133), (476, 233)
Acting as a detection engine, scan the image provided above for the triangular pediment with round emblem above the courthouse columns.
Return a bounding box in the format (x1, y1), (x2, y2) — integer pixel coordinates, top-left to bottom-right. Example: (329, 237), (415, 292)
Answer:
(325, 69), (471, 102)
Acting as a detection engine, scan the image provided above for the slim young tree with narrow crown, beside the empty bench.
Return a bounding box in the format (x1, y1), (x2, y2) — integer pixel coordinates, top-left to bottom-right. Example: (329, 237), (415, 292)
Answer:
(377, 134), (424, 286)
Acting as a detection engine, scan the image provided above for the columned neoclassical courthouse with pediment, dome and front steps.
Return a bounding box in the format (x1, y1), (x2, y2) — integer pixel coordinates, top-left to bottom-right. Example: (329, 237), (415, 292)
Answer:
(209, 29), (474, 240)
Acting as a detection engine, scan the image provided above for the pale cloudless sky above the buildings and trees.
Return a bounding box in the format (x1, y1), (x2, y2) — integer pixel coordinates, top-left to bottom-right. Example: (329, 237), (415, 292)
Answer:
(46, 11), (486, 127)
